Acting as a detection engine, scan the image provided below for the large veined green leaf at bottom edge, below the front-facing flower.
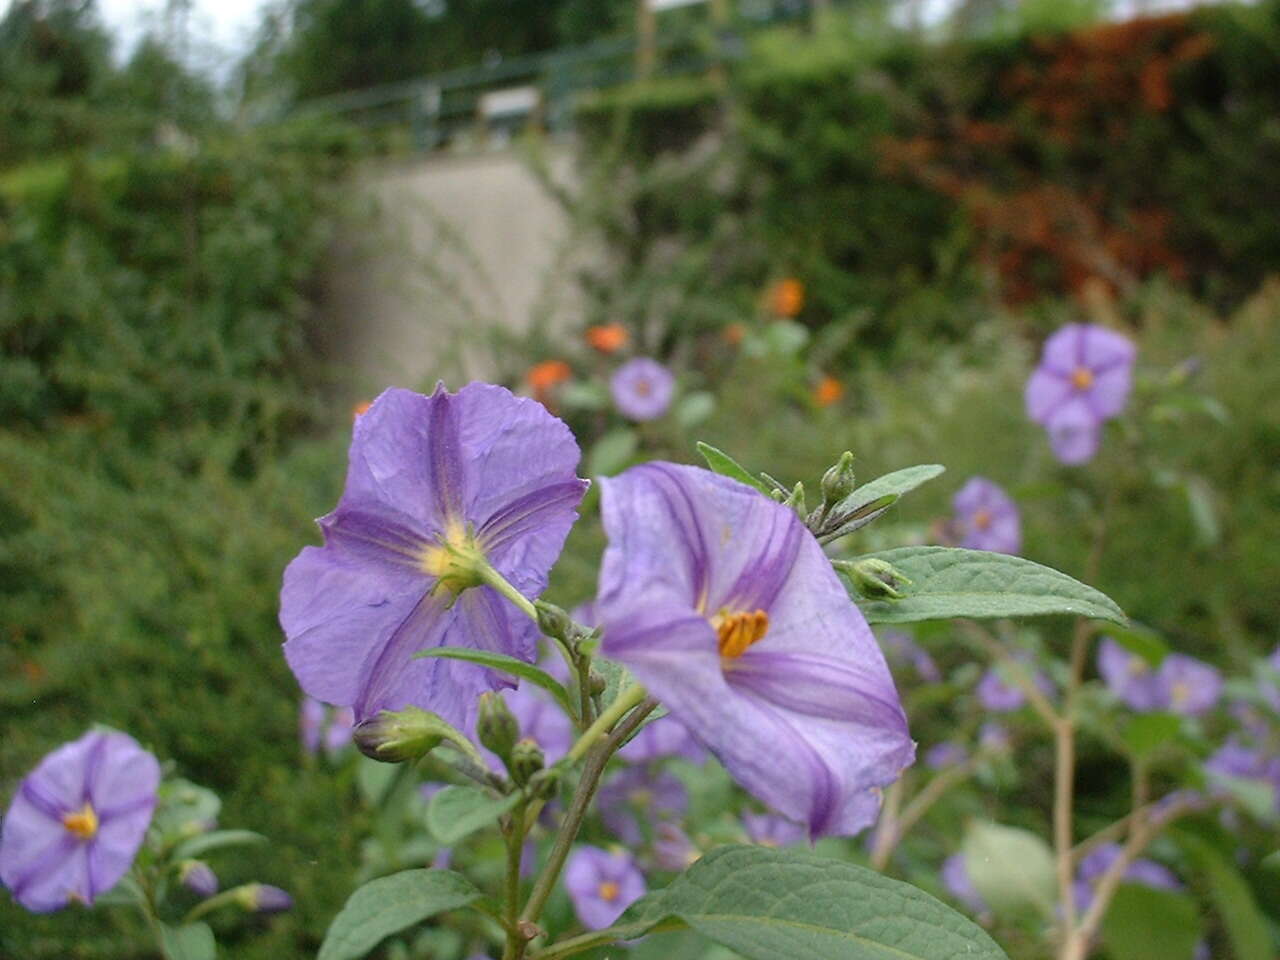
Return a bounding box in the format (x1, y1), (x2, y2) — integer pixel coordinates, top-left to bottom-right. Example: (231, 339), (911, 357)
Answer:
(613, 846), (1005, 960)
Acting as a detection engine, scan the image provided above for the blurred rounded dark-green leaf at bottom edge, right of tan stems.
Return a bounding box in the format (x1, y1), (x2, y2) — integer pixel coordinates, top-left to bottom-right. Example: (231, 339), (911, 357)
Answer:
(1102, 883), (1202, 960)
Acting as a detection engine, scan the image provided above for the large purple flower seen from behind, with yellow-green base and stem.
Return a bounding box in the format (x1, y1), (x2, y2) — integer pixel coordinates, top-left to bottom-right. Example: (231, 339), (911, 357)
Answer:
(280, 383), (586, 728)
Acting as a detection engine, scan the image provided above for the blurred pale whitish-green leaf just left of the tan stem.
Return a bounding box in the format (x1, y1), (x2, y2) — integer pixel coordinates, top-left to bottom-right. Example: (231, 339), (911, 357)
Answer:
(964, 822), (1057, 918)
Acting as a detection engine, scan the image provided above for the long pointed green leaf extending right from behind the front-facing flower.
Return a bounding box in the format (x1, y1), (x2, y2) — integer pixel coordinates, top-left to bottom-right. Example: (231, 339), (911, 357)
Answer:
(851, 547), (1125, 625)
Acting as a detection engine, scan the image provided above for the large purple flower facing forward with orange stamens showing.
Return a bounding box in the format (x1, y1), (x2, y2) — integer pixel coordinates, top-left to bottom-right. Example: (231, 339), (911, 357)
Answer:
(598, 463), (915, 836)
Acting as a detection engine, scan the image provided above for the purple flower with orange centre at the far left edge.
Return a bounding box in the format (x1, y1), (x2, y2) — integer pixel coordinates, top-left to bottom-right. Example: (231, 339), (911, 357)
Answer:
(0, 731), (160, 913)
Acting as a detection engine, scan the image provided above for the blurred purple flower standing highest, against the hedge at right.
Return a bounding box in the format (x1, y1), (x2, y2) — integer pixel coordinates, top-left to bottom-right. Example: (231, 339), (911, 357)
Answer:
(1027, 324), (1137, 463)
